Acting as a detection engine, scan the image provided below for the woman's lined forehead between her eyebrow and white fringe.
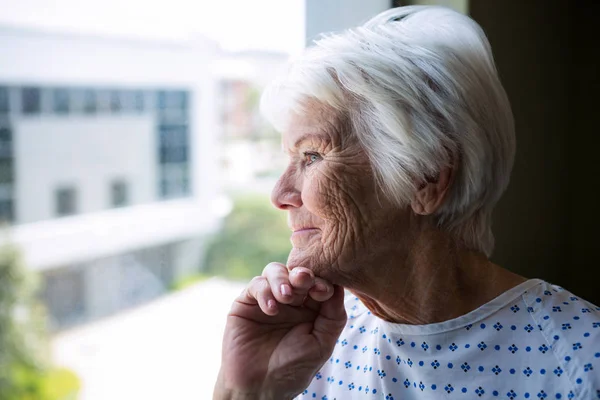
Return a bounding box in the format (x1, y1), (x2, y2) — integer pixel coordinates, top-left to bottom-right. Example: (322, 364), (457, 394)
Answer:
(283, 102), (343, 149)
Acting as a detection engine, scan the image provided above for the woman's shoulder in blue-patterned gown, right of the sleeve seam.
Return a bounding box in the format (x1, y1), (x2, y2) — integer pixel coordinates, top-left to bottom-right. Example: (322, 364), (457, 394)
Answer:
(523, 282), (600, 398)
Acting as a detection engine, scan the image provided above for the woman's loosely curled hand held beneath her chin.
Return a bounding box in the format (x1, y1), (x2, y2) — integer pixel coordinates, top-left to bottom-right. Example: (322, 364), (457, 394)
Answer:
(214, 263), (347, 400)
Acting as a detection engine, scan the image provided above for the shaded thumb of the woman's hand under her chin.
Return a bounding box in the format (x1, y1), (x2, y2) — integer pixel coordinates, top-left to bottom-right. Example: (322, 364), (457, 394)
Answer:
(312, 285), (348, 356)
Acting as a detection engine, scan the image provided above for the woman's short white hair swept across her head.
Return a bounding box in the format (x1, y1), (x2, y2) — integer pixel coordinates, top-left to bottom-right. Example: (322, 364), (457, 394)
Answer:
(261, 6), (515, 256)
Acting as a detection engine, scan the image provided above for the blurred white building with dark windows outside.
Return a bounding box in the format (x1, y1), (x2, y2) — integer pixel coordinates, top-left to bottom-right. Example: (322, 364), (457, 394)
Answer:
(0, 27), (223, 327)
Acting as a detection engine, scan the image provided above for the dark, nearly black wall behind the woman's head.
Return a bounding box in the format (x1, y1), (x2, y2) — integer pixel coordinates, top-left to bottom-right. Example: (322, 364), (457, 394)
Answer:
(469, 0), (600, 304)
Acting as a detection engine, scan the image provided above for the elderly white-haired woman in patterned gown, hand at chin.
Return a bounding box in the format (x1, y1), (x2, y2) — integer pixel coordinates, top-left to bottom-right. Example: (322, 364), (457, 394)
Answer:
(214, 7), (600, 400)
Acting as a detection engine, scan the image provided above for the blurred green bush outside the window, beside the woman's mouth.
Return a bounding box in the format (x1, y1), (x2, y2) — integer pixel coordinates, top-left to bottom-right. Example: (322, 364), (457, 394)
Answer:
(204, 195), (291, 280)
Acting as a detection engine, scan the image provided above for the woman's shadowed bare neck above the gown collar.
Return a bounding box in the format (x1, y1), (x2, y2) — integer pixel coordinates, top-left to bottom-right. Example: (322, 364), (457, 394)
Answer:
(346, 230), (525, 325)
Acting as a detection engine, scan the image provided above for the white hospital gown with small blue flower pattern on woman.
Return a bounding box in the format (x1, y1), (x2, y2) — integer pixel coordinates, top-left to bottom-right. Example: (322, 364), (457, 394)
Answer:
(297, 279), (600, 400)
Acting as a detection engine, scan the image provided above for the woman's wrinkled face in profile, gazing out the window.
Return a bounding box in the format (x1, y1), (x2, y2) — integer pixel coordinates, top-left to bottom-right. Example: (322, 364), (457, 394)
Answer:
(272, 105), (405, 285)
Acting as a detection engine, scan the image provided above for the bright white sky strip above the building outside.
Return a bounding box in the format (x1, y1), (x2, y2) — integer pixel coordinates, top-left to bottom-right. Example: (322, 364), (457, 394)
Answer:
(0, 0), (304, 53)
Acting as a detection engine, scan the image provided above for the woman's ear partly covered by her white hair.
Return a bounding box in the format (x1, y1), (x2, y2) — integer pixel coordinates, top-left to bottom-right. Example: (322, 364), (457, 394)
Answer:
(410, 167), (454, 215)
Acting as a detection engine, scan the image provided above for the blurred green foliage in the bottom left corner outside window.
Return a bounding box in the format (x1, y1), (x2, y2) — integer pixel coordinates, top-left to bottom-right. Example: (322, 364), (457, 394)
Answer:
(0, 242), (79, 400)
